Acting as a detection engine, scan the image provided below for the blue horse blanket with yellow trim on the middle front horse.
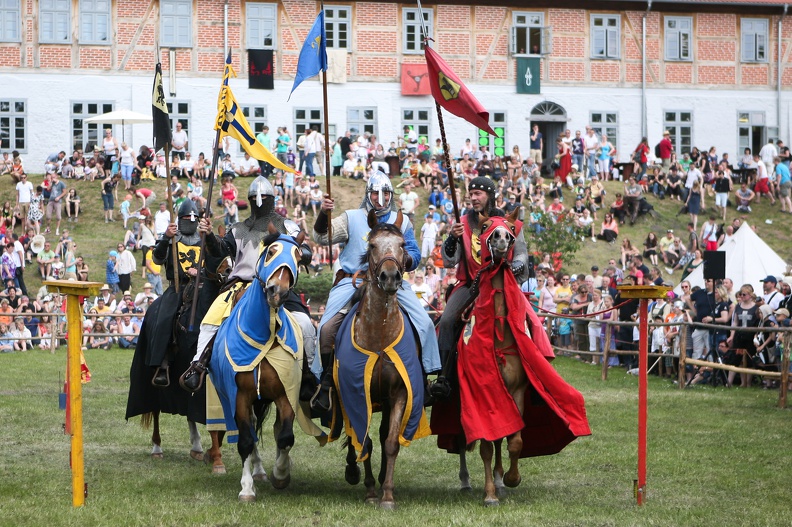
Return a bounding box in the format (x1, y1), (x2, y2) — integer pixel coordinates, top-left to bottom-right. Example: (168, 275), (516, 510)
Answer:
(330, 304), (431, 461)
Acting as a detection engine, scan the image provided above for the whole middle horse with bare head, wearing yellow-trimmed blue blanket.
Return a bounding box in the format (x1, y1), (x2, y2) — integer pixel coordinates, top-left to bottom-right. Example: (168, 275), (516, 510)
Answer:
(333, 211), (429, 509)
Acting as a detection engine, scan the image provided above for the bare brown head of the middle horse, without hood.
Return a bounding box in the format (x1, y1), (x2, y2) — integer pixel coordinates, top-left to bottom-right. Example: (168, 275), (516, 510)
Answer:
(361, 210), (407, 295)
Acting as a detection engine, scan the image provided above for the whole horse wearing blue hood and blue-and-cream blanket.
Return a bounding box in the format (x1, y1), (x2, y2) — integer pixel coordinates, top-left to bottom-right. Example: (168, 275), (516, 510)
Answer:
(209, 229), (323, 501)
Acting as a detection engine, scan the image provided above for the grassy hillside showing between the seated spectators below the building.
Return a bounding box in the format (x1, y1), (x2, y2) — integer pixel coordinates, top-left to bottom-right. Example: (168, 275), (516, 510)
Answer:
(0, 174), (792, 304)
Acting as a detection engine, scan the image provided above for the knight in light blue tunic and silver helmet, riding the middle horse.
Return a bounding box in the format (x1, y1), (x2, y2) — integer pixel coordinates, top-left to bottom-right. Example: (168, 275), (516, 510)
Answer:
(311, 170), (441, 412)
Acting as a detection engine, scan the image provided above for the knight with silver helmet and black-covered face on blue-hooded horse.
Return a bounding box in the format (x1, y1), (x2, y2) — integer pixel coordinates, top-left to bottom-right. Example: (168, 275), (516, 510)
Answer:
(180, 176), (318, 392)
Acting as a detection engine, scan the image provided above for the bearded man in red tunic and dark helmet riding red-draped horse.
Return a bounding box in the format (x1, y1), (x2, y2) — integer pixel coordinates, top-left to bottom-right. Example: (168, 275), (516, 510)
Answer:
(431, 176), (528, 399)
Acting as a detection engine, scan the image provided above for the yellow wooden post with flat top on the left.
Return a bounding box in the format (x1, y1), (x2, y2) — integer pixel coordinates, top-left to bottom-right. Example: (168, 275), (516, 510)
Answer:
(44, 280), (102, 507)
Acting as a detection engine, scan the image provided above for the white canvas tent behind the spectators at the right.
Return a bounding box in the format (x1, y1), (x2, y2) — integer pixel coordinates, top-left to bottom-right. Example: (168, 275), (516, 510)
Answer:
(674, 222), (787, 295)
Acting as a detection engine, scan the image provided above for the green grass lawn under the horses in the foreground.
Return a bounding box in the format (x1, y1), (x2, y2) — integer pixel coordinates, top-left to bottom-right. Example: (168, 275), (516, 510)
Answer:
(0, 348), (792, 527)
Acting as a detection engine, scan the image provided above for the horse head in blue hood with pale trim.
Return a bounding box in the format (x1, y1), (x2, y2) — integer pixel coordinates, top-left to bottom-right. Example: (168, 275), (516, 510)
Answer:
(256, 223), (305, 309)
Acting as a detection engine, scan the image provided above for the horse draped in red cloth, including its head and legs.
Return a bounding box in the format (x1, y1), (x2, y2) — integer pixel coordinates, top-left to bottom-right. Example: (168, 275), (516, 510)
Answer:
(457, 210), (590, 506)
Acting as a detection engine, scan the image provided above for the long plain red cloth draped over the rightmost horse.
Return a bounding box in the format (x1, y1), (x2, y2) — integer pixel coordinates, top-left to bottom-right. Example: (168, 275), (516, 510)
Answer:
(432, 264), (591, 457)
